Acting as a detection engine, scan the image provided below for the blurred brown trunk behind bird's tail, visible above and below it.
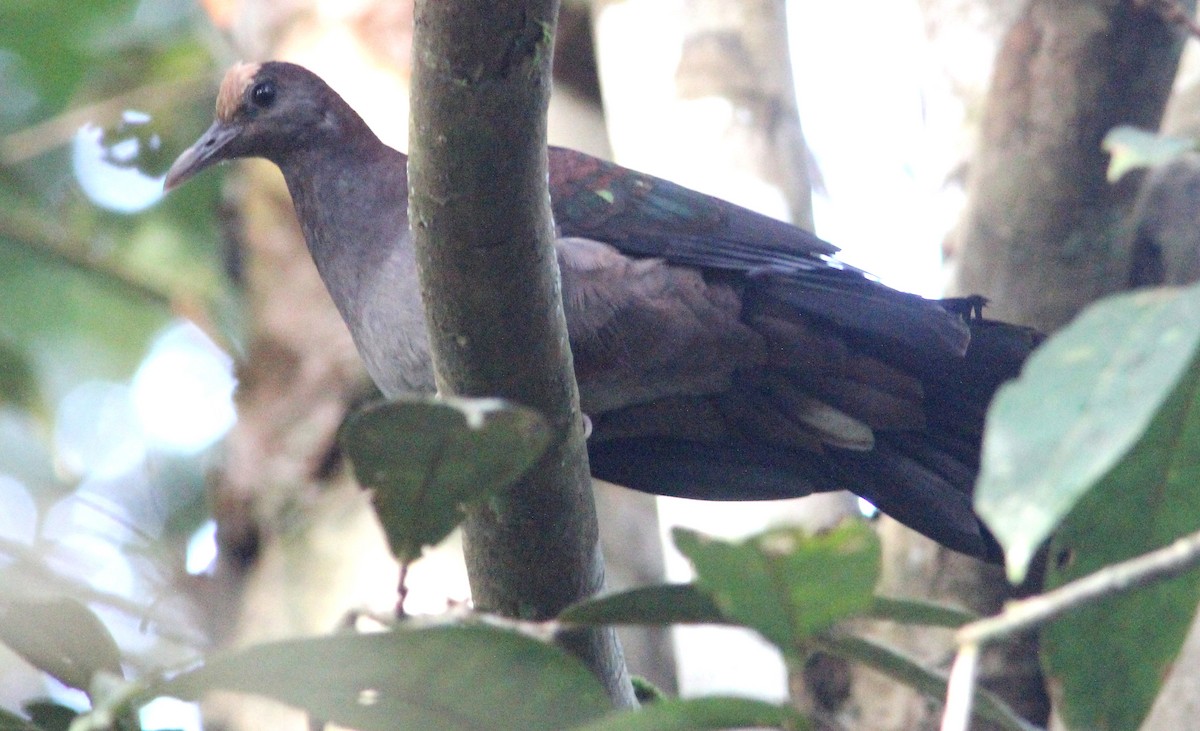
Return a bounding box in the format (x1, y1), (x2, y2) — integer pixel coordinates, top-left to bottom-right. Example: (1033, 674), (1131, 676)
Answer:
(866, 0), (1194, 729)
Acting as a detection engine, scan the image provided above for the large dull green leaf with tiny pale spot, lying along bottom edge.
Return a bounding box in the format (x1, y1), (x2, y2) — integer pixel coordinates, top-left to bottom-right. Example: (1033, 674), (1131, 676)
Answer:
(164, 625), (612, 731)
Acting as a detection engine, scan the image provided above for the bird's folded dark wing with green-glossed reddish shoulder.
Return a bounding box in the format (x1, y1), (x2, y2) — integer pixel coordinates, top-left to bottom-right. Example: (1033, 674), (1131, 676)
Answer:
(548, 148), (970, 354)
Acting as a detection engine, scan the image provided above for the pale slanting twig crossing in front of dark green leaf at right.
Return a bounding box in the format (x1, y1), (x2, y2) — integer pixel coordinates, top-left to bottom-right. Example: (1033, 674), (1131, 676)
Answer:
(955, 523), (1200, 647)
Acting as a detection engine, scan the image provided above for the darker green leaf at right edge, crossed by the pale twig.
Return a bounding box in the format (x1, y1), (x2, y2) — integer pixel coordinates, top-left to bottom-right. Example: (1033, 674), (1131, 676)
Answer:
(1040, 357), (1200, 731)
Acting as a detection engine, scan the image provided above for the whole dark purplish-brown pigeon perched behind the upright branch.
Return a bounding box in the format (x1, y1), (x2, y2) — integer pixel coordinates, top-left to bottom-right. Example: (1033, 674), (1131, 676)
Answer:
(164, 61), (1039, 562)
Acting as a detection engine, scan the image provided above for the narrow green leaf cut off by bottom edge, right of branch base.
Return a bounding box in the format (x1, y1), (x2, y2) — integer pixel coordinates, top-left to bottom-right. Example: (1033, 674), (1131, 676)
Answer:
(572, 696), (811, 731)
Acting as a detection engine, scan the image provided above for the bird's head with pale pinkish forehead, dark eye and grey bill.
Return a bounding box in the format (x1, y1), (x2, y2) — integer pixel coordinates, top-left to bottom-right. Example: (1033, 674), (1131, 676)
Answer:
(163, 61), (350, 191)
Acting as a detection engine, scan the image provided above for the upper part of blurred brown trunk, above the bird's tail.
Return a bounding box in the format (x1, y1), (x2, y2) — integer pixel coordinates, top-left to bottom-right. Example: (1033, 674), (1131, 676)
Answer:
(954, 0), (1195, 331)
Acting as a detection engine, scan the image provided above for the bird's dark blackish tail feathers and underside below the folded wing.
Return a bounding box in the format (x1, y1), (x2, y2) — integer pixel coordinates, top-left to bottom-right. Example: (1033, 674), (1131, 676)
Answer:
(589, 300), (1040, 561)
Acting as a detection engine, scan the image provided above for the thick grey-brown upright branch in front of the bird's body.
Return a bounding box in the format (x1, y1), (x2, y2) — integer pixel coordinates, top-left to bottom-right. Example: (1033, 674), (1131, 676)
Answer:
(410, 0), (632, 703)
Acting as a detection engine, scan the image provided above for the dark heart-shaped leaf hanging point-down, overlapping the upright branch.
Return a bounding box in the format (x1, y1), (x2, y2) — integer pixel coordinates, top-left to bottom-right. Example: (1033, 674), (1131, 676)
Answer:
(342, 396), (550, 562)
